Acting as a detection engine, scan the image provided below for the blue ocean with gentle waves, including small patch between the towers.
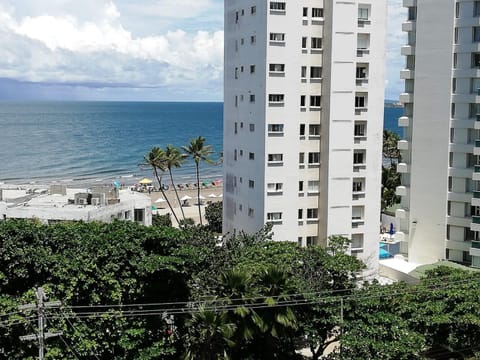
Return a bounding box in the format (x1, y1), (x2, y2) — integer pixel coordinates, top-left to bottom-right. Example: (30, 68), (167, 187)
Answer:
(0, 102), (403, 184)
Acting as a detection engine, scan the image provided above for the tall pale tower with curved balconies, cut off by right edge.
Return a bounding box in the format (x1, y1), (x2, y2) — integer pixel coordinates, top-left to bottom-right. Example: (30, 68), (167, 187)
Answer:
(396, 0), (480, 267)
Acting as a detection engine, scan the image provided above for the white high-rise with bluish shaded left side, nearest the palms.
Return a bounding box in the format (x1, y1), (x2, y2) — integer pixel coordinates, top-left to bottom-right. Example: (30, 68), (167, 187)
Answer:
(223, 0), (386, 263)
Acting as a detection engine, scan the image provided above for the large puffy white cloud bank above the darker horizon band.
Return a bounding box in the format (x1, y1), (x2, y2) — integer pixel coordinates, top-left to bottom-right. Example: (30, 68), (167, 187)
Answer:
(0, 2), (223, 99)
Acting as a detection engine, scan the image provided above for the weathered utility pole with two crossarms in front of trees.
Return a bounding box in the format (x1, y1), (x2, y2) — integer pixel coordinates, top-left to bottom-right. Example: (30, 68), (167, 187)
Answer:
(18, 287), (62, 360)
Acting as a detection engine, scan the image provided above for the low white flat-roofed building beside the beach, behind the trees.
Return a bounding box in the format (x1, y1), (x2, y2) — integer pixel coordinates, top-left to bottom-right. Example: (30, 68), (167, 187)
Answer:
(0, 186), (152, 226)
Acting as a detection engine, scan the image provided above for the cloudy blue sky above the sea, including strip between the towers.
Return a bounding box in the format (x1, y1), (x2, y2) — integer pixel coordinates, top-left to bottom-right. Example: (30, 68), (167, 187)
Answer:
(0, 0), (406, 101)
